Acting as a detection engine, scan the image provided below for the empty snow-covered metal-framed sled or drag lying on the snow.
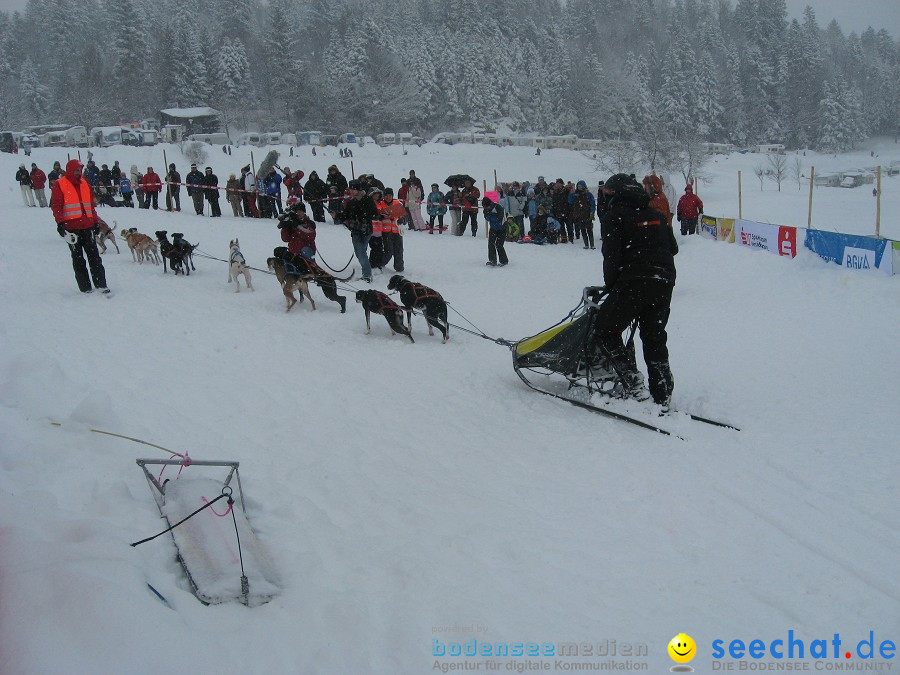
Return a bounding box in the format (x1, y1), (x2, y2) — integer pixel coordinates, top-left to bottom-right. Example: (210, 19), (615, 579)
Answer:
(137, 459), (281, 607)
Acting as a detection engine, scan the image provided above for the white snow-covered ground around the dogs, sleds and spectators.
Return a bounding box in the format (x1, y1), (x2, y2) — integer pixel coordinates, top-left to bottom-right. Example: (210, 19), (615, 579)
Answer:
(0, 143), (900, 674)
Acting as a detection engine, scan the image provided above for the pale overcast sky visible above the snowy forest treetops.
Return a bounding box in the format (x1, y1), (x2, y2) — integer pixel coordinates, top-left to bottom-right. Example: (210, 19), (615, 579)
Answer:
(0, 0), (900, 39)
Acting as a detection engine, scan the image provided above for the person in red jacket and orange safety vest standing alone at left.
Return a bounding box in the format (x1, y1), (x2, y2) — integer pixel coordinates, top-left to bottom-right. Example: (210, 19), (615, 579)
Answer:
(50, 159), (109, 294)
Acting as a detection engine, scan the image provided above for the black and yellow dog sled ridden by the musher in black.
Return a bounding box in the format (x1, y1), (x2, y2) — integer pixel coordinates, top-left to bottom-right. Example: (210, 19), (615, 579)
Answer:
(511, 286), (738, 436)
